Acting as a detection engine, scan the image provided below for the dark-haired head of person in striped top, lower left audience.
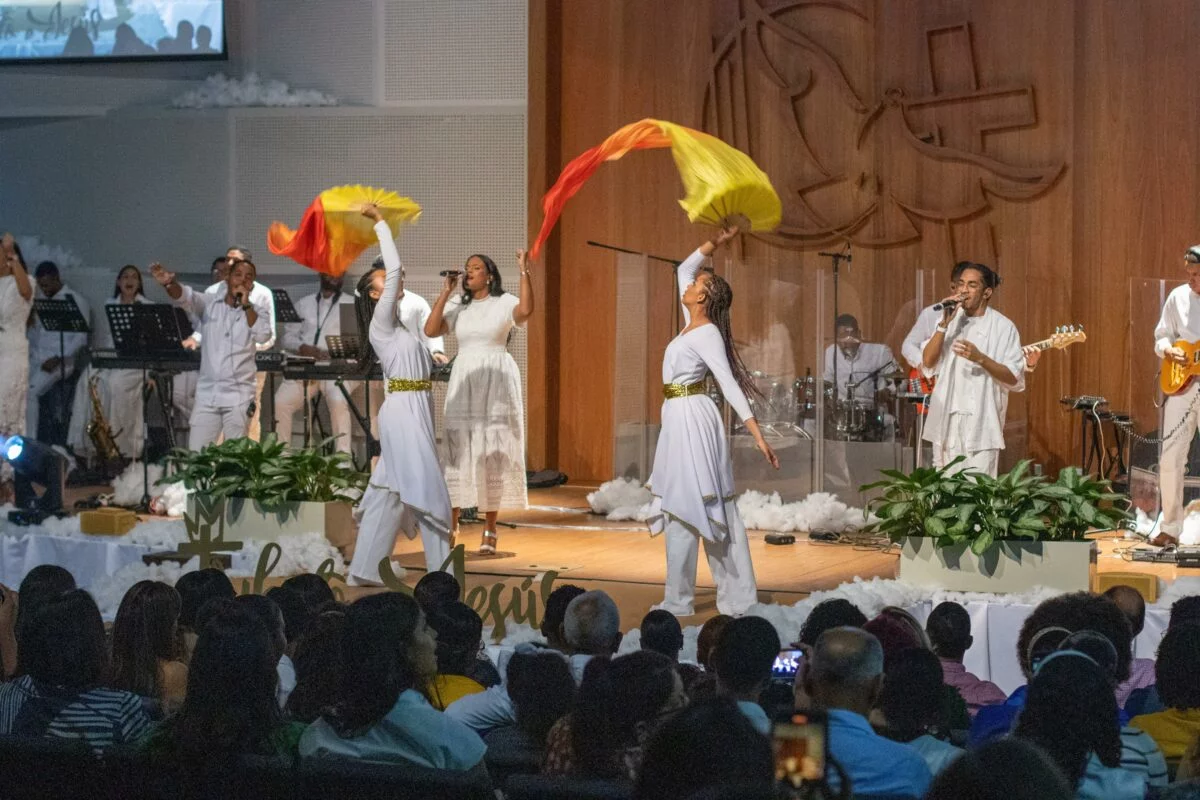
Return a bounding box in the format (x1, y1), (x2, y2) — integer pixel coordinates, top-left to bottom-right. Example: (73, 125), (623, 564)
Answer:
(17, 589), (110, 692)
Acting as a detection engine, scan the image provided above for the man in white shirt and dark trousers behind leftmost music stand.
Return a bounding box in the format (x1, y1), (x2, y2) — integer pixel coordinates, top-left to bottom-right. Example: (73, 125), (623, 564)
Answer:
(25, 261), (91, 445)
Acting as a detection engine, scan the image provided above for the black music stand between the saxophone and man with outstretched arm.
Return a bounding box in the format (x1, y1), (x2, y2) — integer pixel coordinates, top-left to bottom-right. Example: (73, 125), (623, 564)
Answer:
(104, 302), (192, 511)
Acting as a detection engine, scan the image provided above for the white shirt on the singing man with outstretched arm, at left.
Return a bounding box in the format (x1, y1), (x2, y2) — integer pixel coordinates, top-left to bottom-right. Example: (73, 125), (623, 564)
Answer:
(172, 287), (274, 408)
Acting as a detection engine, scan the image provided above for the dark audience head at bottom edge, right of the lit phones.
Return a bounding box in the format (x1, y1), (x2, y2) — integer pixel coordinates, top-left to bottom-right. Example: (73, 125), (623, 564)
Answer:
(925, 739), (1075, 800)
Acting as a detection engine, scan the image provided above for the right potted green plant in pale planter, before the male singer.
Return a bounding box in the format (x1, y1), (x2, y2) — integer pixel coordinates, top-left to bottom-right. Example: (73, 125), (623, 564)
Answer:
(863, 459), (1130, 591)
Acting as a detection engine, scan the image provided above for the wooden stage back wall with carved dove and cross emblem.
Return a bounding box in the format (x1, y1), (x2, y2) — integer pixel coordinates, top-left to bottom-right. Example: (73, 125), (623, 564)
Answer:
(530, 0), (1200, 480)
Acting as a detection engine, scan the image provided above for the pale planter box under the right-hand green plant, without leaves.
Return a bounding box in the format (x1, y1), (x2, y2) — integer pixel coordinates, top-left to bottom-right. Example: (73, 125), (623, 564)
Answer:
(900, 536), (1096, 594)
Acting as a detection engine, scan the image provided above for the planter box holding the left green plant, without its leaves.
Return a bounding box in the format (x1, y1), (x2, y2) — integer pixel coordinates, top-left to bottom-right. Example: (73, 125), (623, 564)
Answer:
(187, 494), (356, 553)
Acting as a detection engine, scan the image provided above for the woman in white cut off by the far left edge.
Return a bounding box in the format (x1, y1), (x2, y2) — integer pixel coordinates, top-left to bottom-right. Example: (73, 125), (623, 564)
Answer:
(0, 234), (34, 503)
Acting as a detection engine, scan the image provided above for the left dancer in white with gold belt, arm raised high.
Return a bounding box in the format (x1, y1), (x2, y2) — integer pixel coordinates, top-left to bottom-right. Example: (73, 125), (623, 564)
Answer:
(348, 205), (450, 585)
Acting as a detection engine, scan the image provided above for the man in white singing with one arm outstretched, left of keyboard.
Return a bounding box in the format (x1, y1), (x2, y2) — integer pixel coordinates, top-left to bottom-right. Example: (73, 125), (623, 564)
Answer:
(150, 260), (274, 450)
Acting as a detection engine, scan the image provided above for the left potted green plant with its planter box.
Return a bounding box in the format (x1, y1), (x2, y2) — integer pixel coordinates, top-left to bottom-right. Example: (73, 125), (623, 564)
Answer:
(162, 433), (368, 547)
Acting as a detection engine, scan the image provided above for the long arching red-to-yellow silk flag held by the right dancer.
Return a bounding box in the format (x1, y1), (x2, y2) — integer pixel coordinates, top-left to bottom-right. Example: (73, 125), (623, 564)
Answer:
(529, 119), (784, 258)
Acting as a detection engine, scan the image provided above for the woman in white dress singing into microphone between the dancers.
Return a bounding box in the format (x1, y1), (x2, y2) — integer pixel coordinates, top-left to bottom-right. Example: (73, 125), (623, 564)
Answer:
(425, 249), (533, 554)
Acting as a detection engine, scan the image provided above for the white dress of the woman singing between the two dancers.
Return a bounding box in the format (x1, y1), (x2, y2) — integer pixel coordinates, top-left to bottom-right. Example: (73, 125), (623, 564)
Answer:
(442, 294), (528, 512)
